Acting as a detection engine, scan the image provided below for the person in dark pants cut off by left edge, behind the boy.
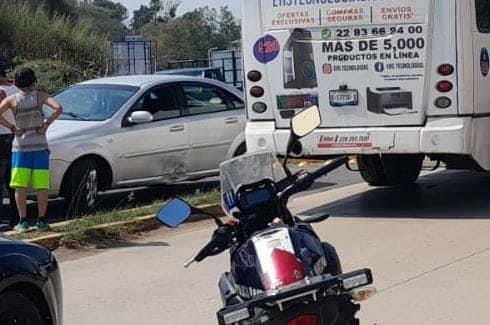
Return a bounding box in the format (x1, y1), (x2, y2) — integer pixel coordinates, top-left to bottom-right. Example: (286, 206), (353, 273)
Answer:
(0, 66), (19, 226)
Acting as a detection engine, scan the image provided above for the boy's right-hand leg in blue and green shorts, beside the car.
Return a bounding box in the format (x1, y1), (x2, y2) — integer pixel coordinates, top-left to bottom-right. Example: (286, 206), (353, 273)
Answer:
(32, 150), (49, 230)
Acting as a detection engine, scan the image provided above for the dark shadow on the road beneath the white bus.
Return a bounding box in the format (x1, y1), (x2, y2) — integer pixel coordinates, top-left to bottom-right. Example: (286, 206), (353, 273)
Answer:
(309, 171), (490, 219)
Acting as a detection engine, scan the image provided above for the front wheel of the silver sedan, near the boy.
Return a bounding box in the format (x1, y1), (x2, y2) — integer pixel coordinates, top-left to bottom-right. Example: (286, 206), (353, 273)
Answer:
(65, 159), (99, 215)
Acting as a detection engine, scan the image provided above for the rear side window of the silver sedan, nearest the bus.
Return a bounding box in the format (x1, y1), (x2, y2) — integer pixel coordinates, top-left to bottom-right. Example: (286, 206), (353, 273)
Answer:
(182, 83), (229, 115)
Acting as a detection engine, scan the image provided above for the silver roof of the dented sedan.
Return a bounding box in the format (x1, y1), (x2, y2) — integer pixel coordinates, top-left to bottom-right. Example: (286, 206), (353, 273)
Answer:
(79, 74), (243, 98)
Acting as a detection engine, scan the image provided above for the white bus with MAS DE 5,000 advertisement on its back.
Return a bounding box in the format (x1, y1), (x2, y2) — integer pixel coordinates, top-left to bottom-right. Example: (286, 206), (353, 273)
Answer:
(242, 0), (490, 186)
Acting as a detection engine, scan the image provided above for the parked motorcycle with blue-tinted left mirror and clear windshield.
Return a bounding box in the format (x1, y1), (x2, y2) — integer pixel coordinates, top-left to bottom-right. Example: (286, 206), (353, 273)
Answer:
(157, 106), (375, 325)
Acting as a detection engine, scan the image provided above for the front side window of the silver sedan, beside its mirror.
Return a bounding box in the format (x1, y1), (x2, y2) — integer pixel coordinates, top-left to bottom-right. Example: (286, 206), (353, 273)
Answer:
(132, 86), (181, 121)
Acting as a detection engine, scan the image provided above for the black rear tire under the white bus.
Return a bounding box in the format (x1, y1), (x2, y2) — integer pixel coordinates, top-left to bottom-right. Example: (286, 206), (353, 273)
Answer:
(357, 155), (424, 186)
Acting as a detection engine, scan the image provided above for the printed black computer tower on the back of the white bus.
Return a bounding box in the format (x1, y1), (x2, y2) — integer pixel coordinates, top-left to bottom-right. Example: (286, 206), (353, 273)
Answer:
(283, 28), (318, 89)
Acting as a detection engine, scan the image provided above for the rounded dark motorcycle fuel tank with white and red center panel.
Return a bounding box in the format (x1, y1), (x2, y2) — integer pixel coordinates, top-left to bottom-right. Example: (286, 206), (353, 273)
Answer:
(231, 225), (326, 296)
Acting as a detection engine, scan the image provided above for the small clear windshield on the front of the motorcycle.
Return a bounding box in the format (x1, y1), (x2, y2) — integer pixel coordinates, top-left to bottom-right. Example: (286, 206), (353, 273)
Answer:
(219, 151), (286, 211)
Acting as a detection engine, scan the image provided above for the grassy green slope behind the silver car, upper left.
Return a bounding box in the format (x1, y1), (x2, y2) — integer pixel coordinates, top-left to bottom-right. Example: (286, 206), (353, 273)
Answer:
(0, 0), (128, 93)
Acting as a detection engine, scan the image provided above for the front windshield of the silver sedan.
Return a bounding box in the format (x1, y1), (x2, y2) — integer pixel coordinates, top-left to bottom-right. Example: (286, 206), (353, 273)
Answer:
(48, 84), (139, 121)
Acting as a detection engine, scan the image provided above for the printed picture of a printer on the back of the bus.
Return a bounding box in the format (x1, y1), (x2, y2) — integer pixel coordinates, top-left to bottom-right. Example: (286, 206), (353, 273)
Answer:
(367, 87), (417, 115)
